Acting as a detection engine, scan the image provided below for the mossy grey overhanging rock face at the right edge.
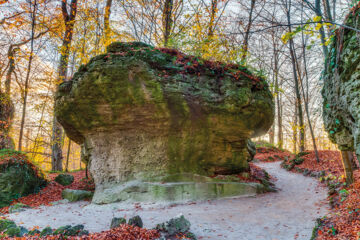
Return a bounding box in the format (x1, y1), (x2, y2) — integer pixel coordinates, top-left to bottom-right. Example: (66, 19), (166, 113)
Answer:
(323, 5), (360, 159)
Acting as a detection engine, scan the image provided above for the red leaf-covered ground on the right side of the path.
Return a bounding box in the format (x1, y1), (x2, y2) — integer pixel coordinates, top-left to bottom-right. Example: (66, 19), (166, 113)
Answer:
(280, 150), (360, 240)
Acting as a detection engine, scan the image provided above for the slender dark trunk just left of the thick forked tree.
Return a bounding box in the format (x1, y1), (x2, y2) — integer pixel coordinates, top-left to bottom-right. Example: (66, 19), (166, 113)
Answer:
(18, 0), (37, 151)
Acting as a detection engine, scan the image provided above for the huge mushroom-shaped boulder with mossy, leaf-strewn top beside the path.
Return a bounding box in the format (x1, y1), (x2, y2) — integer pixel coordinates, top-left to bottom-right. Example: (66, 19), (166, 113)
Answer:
(55, 42), (274, 203)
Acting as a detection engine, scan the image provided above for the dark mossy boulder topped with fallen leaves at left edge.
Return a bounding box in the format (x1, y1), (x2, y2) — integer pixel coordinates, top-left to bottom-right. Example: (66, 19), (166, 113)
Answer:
(0, 149), (47, 207)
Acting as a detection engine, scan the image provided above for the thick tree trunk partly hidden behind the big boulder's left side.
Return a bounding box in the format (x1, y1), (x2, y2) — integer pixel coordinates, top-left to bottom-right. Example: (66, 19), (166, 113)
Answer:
(51, 0), (77, 171)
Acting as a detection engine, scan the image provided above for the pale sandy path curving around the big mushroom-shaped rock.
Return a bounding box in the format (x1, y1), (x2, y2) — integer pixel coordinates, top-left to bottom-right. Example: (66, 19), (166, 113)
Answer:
(8, 162), (327, 240)
